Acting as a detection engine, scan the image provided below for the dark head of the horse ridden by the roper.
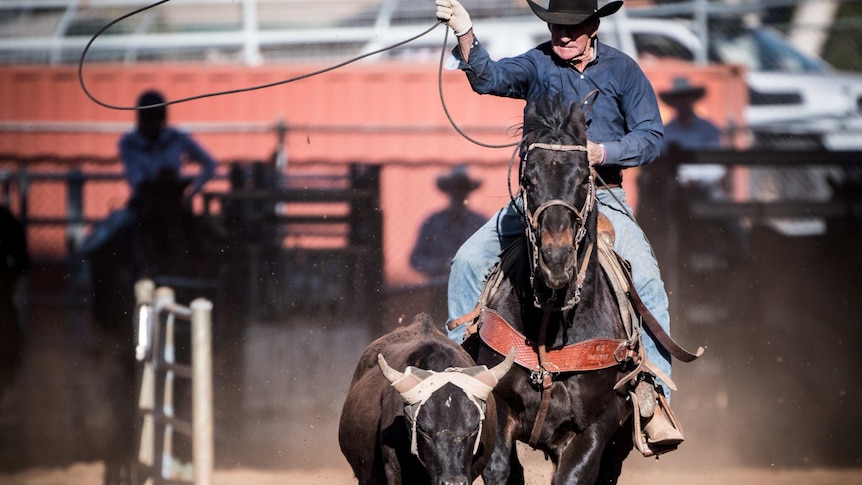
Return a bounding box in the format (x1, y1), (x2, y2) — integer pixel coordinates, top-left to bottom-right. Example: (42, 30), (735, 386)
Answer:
(521, 95), (595, 302)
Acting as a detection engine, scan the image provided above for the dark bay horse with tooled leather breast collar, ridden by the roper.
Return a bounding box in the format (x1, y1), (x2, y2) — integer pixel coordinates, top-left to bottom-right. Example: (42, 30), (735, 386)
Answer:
(464, 98), (638, 485)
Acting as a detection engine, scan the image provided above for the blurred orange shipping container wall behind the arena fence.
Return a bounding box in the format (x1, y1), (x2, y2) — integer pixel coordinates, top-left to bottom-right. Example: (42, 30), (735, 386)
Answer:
(0, 62), (747, 284)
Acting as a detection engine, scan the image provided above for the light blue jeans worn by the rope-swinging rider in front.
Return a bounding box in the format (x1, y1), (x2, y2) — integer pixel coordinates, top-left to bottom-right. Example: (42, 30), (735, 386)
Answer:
(448, 188), (671, 395)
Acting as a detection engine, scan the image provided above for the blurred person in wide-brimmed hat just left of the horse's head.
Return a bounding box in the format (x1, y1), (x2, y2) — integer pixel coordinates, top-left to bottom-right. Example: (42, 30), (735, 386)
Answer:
(410, 165), (488, 278)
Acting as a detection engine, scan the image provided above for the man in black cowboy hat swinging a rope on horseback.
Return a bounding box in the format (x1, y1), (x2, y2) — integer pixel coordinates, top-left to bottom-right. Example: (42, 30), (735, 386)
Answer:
(436, 0), (683, 447)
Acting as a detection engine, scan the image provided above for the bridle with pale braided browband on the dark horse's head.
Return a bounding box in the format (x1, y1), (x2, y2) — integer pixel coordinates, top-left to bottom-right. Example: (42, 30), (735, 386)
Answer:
(521, 143), (596, 311)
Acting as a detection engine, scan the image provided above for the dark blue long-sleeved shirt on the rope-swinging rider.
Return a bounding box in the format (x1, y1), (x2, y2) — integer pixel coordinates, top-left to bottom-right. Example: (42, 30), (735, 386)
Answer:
(453, 35), (663, 168)
